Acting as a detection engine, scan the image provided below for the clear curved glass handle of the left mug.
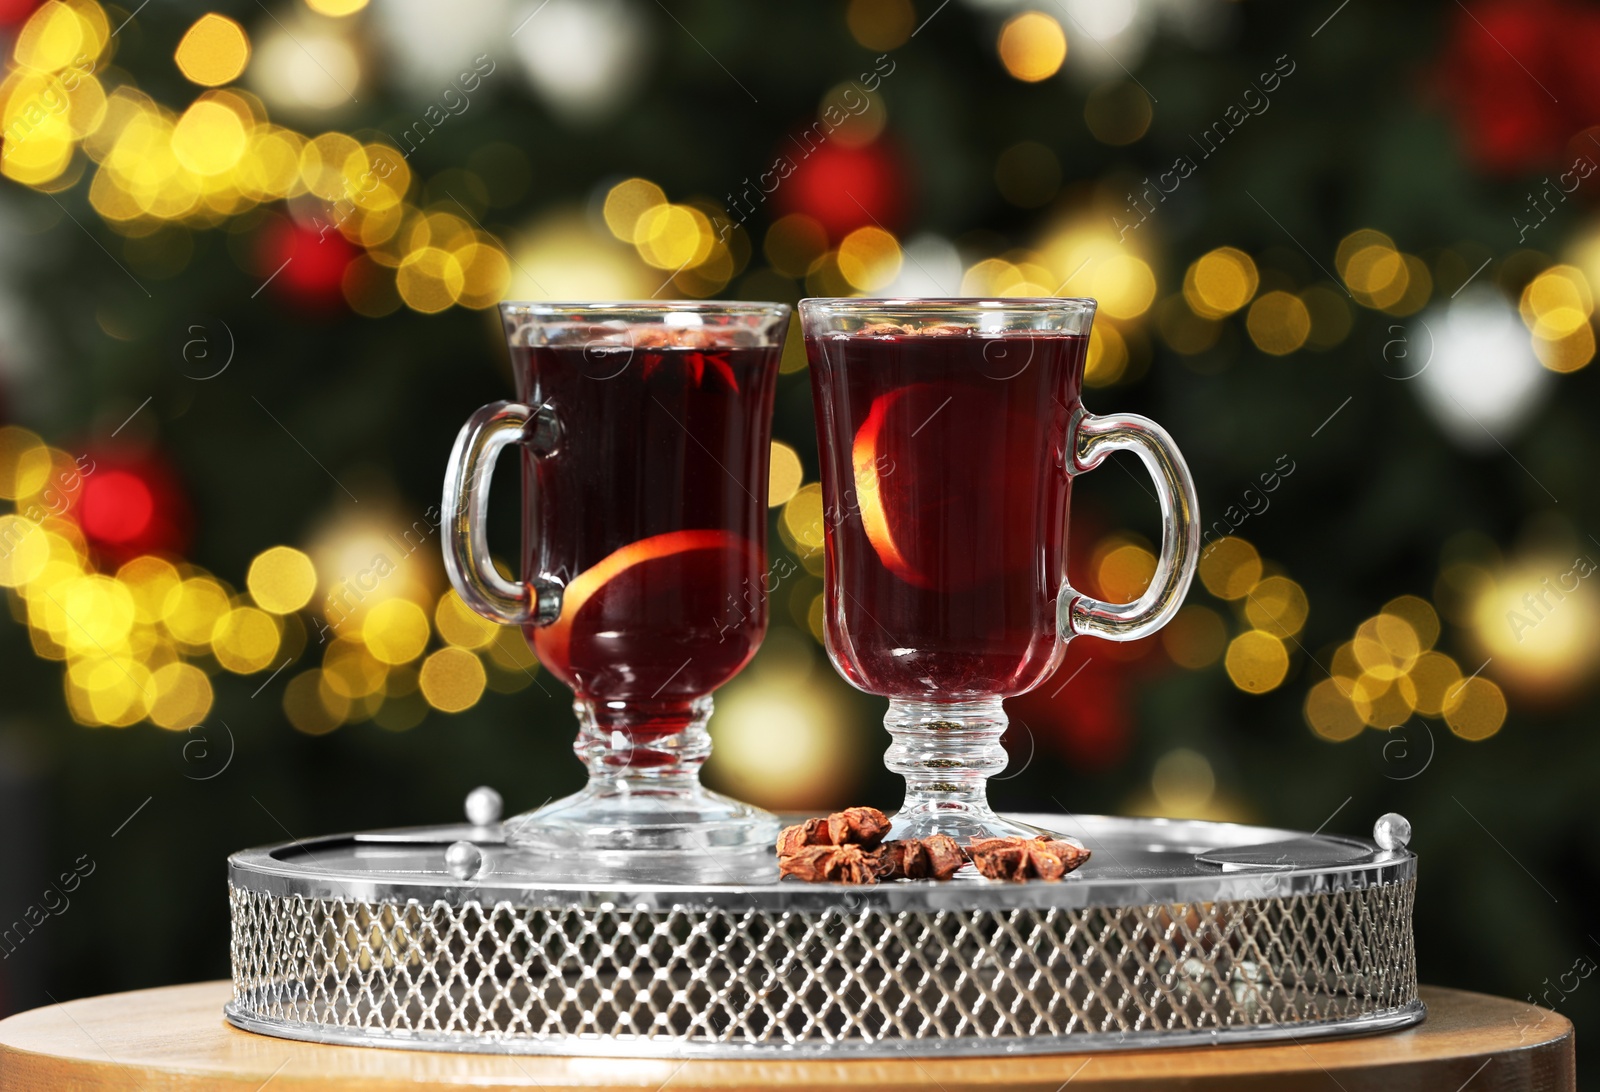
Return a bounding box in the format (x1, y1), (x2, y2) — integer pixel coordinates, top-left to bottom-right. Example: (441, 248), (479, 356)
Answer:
(443, 402), (562, 626)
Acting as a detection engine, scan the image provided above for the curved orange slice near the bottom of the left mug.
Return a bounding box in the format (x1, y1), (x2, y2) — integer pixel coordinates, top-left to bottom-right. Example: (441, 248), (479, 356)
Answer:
(533, 530), (762, 676)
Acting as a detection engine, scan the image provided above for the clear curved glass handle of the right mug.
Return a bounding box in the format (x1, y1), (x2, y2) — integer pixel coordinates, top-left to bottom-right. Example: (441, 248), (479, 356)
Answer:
(1056, 408), (1200, 640)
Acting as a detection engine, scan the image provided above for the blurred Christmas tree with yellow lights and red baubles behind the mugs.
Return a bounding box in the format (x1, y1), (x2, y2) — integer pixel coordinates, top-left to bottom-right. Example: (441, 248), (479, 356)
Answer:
(0, 0), (1600, 1069)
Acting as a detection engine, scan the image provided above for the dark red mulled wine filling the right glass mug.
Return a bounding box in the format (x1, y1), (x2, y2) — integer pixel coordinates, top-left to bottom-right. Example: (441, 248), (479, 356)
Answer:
(806, 331), (1088, 700)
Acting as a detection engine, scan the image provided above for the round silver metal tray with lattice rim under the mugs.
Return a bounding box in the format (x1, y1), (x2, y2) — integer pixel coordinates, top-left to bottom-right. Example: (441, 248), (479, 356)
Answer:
(227, 815), (1424, 1057)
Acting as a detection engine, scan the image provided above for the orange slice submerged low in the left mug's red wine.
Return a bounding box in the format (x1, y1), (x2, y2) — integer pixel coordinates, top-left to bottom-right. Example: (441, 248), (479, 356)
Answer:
(533, 530), (762, 676)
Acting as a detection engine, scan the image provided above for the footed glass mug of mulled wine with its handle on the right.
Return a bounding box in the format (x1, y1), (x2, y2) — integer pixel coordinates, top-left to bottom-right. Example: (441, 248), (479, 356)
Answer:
(800, 299), (1200, 841)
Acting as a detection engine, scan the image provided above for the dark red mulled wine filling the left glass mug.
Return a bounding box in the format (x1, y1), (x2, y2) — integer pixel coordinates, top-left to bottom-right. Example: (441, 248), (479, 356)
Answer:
(514, 330), (779, 737)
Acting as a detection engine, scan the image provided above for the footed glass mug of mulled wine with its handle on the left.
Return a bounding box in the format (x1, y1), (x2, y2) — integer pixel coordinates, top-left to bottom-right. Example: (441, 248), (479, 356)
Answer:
(445, 301), (789, 879)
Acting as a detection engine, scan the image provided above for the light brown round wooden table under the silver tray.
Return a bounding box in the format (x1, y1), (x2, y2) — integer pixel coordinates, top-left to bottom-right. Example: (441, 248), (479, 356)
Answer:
(0, 982), (1578, 1092)
